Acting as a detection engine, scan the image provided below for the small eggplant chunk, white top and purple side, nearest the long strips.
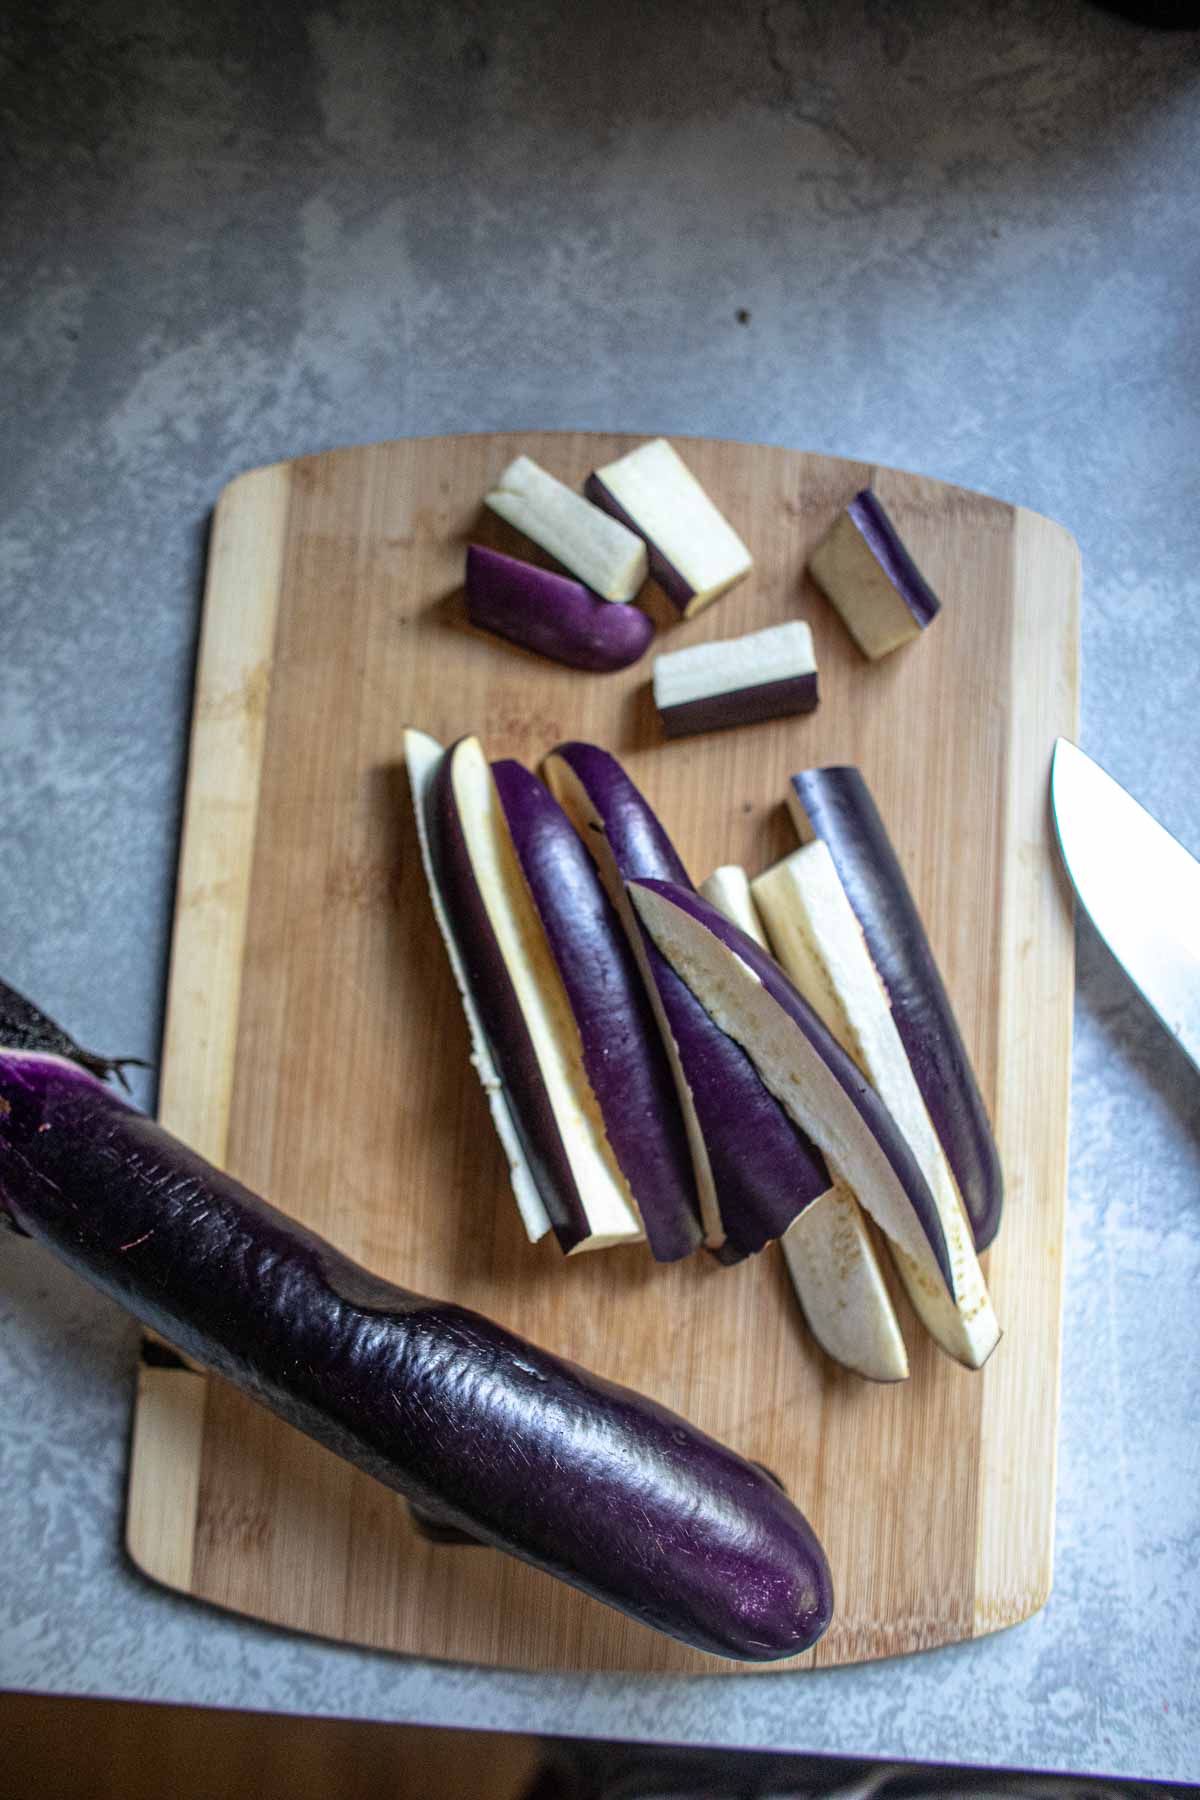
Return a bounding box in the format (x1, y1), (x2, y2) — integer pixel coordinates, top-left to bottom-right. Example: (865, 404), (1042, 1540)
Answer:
(653, 619), (819, 738)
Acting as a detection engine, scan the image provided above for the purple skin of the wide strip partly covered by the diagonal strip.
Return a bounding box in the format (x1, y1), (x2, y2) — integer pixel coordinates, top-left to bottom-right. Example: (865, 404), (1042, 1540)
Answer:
(547, 743), (831, 1262)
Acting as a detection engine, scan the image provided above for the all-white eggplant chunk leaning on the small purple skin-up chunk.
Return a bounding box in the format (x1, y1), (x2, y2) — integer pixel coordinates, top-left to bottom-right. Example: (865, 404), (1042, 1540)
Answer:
(484, 455), (648, 601)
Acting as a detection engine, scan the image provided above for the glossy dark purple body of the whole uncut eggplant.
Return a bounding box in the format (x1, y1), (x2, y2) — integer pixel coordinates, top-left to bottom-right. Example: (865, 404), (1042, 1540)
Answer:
(0, 1029), (833, 1661)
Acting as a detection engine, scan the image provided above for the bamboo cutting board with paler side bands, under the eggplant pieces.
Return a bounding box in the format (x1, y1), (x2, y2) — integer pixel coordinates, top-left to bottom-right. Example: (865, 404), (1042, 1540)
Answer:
(128, 432), (1079, 1672)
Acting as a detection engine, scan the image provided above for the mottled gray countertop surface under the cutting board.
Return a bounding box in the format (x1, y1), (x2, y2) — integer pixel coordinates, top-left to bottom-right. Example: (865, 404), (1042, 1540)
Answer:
(0, 0), (1200, 1778)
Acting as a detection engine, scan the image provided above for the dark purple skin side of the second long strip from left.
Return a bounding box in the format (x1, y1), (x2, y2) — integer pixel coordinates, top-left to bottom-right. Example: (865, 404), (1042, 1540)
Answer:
(437, 740), (590, 1251)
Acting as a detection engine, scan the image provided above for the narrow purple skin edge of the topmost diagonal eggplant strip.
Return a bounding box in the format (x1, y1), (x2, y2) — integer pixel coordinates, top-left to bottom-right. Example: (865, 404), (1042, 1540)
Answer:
(635, 880), (954, 1296)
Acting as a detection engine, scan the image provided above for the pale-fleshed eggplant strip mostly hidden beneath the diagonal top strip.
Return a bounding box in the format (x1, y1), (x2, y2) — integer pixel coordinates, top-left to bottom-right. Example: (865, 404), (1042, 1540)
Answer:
(700, 862), (909, 1381)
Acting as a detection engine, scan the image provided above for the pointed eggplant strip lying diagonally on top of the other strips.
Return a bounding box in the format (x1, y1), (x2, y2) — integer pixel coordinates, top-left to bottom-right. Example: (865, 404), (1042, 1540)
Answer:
(628, 880), (954, 1296)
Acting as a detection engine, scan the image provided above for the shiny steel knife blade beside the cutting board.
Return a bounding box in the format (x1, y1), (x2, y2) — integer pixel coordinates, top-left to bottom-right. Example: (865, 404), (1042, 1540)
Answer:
(1051, 738), (1200, 1069)
